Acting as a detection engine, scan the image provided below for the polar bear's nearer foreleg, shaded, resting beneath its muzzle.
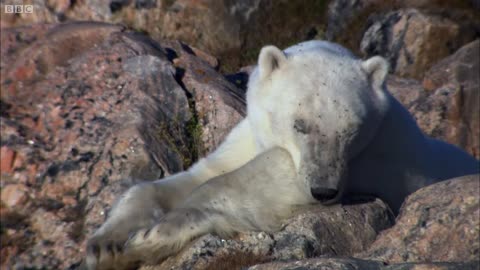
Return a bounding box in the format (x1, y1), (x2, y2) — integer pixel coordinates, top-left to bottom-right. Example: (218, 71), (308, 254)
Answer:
(124, 148), (314, 264)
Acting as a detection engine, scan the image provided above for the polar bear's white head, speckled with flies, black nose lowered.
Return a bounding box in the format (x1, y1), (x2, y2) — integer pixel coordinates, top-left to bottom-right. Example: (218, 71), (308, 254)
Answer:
(247, 41), (388, 204)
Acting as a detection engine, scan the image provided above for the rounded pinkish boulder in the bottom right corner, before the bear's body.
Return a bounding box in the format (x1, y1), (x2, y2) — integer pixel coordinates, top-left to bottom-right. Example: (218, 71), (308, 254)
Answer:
(355, 175), (480, 263)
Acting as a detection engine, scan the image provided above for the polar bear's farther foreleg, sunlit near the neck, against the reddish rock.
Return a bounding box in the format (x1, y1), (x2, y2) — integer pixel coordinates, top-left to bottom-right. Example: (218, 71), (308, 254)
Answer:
(86, 119), (257, 269)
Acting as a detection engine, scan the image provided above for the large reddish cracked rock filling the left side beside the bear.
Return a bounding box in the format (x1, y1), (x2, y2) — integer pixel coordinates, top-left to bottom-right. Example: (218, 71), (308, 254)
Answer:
(0, 22), (245, 269)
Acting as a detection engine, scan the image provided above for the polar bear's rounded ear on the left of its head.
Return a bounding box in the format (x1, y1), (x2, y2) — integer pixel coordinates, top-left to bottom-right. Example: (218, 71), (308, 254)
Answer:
(258, 46), (287, 80)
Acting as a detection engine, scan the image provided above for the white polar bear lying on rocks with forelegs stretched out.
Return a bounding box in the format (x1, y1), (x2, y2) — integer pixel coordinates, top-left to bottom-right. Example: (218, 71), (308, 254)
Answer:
(86, 41), (479, 269)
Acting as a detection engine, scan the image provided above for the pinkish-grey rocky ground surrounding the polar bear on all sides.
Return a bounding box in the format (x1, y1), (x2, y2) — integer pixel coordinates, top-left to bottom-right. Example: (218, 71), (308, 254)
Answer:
(0, 0), (480, 270)
